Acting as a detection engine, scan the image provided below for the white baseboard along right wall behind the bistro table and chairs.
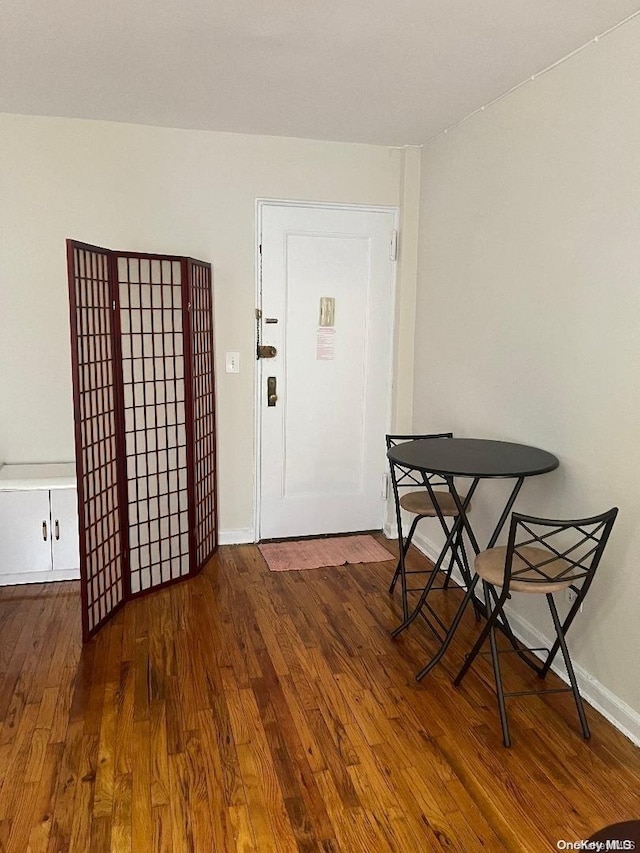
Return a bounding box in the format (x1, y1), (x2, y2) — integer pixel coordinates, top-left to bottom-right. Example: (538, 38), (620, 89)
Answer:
(410, 530), (640, 746)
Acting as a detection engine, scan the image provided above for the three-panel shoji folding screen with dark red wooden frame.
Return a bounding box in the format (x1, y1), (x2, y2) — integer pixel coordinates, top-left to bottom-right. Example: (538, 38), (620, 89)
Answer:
(67, 240), (217, 639)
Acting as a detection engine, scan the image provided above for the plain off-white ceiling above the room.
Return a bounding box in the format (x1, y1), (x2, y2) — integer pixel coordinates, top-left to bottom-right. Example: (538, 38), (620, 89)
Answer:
(0, 0), (640, 145)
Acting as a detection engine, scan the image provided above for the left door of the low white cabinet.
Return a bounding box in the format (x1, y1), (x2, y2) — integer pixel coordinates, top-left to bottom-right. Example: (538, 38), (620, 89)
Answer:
(0, 489), (51, 575)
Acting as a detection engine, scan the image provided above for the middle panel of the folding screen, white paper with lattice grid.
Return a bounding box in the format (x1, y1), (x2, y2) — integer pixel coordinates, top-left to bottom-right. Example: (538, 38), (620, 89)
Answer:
(118, 257), (190, 594)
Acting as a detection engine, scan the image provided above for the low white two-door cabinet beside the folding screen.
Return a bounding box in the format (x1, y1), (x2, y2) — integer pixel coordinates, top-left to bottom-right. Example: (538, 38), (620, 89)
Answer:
(0, 463), (80, 586)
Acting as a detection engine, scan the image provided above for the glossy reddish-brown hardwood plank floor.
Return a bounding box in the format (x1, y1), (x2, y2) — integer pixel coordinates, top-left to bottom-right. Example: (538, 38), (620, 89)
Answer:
(0, 538), (640, 853)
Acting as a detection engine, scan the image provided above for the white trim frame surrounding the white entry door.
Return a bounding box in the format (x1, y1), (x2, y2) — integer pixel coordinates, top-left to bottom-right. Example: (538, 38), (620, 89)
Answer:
(253, 198), (400, 542)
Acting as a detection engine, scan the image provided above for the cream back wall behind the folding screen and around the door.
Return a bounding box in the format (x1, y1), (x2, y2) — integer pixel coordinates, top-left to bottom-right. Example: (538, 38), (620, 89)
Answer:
(0, 115), (406, 531)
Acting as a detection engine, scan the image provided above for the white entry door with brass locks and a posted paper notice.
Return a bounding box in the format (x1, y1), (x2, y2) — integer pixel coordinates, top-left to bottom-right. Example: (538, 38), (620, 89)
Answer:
(259, 202), (396, 539)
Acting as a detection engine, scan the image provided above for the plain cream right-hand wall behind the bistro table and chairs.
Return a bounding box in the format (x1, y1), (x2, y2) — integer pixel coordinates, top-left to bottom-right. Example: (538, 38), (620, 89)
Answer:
(414, 19), (640, 720)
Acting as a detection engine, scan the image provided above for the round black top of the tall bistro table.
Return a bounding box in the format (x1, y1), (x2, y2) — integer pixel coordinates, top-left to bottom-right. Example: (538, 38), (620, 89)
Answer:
(387, 438), (560, 478)
